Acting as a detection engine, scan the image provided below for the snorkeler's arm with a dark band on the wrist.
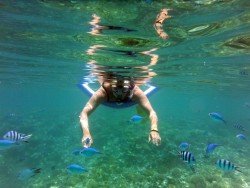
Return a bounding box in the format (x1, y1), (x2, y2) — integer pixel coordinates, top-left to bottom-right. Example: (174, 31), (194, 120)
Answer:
(134, 87), (161, 145)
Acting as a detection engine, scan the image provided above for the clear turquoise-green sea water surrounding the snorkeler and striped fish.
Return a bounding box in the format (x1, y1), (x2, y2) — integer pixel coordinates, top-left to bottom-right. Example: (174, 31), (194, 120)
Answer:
(0, 0), (250, 188)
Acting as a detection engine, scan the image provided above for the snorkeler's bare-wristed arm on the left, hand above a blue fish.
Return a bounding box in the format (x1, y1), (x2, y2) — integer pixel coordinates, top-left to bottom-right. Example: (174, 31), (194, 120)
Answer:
(79, 88), (105, 147)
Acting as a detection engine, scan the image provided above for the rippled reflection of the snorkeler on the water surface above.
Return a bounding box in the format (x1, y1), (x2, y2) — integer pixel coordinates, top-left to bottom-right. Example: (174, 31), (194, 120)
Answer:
(85, 8), (170, 85)
